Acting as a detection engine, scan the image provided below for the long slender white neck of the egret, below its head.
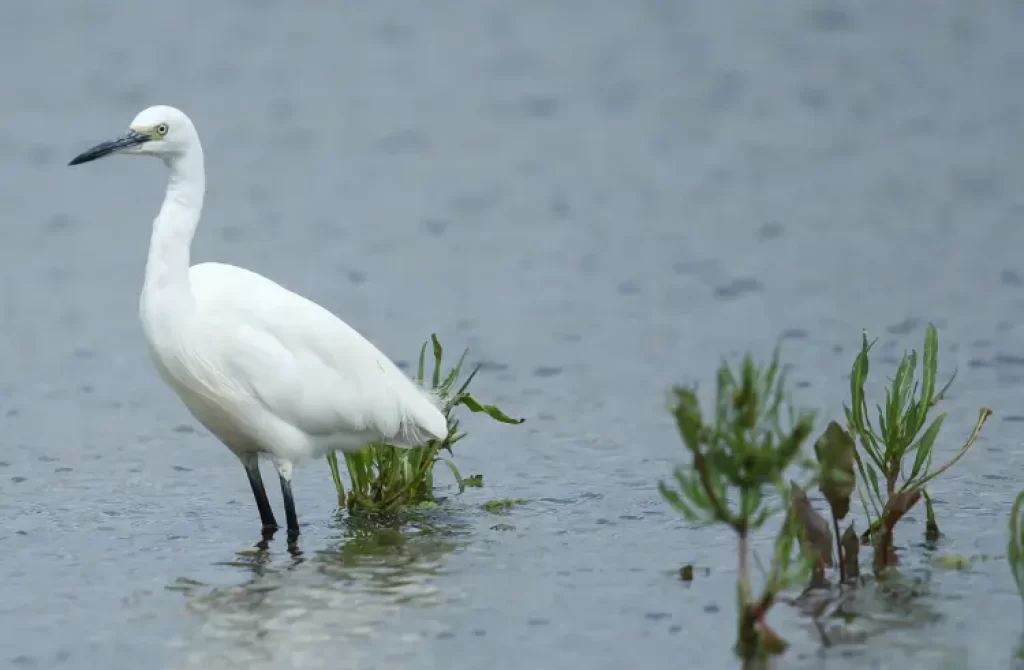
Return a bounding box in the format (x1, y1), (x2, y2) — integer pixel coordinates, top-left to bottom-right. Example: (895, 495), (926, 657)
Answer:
(142, 147), (206, 305)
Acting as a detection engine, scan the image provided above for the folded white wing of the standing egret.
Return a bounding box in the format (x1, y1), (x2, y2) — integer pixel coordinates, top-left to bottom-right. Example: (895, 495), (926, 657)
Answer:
(193, 263), (447, 444)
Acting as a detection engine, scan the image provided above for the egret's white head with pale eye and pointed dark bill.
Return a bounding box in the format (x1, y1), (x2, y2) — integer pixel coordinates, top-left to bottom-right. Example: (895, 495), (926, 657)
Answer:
(68, 104), (199, 165)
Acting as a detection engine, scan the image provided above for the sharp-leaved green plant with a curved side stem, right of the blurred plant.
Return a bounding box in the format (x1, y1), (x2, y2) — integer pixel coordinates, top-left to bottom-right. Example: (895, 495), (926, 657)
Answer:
(844, 324), (991, 572)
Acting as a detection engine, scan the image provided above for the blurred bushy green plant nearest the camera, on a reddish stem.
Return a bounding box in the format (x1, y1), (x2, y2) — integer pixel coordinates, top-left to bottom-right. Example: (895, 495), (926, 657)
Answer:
(658, 349), (819, 660)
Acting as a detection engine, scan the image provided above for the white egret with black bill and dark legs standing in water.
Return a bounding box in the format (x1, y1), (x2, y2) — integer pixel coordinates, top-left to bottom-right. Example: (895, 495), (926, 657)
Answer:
(69, 106), (447, 538)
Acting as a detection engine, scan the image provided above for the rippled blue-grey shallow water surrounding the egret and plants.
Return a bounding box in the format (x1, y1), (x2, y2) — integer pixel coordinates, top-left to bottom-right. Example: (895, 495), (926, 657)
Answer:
(0, 0), (1024, 670)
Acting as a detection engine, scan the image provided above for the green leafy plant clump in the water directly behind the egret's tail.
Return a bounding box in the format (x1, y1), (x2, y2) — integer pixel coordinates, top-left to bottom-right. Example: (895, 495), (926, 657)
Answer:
(327, 334), (524, 511)
